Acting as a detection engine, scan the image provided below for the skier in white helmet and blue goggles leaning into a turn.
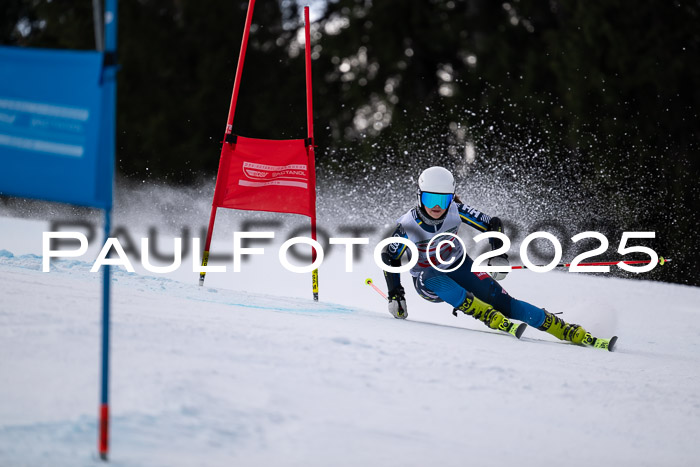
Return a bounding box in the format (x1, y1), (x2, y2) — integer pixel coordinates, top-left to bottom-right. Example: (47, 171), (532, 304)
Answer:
(382, 167), (614, 350)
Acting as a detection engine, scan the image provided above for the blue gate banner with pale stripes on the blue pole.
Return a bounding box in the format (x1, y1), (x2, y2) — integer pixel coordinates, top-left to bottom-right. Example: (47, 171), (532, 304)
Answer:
(0, 47), (114, 209)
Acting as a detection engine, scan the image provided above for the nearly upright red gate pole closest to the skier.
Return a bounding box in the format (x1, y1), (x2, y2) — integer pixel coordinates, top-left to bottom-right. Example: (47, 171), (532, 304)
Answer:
(304, 6), (318, 301)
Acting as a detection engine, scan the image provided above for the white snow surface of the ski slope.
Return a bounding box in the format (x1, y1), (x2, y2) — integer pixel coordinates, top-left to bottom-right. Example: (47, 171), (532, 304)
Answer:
(0, 209), (700, 466)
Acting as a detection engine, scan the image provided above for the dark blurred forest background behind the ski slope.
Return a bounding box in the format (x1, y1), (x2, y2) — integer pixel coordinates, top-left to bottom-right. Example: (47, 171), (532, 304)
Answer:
(0, 0), (700, 285)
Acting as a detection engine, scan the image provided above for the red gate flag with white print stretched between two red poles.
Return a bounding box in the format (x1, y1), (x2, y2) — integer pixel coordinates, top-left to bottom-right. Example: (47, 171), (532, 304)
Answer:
(214, 136), (315, 217)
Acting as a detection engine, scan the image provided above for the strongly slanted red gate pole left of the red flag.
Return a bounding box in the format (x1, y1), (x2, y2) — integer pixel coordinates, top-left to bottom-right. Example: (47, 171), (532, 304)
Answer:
(199, 0), (255, 286)
